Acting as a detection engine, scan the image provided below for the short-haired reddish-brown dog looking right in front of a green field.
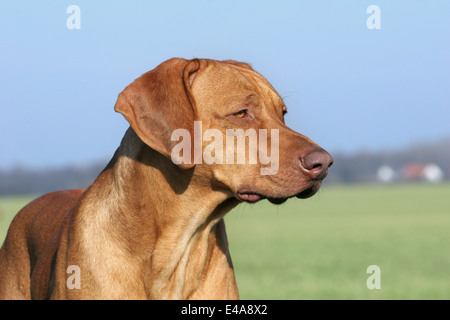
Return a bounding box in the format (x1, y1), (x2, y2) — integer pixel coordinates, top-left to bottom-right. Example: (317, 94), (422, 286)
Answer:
(0, 59), (332, 299)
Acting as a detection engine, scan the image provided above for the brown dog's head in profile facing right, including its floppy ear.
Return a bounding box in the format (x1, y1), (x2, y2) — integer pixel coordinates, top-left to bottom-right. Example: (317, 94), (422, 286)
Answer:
(115, 59), (333, 203)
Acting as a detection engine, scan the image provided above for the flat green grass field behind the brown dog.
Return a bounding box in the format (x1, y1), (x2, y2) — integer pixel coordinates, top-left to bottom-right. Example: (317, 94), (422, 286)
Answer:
(0, 184), (450, 299)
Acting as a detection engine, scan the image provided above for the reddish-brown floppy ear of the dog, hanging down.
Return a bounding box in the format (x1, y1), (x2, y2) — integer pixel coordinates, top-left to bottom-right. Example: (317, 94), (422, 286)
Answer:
(114, 58), (201, 168)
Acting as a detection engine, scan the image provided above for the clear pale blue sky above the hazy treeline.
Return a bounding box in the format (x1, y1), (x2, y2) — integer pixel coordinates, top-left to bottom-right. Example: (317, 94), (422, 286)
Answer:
(0, 0), (450, 169)
